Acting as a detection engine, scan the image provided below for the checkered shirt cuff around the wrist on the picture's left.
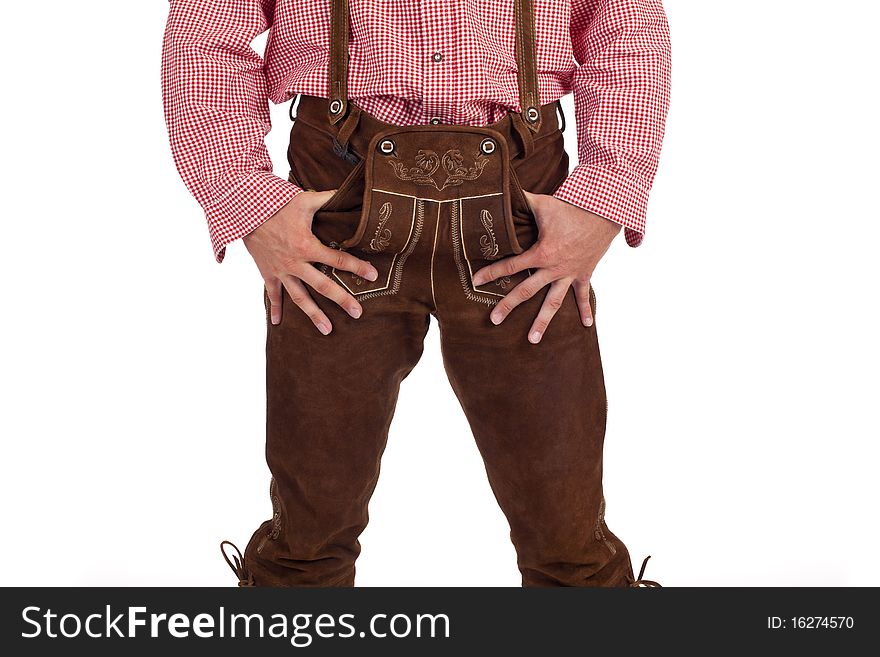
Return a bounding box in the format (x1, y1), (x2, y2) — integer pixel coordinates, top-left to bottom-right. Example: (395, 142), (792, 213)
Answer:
(205, 171), (304, 262)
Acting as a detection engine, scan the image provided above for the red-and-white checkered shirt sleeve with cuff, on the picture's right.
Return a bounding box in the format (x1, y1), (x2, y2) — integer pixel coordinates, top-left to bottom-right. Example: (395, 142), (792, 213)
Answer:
(554, 0), (671, 246)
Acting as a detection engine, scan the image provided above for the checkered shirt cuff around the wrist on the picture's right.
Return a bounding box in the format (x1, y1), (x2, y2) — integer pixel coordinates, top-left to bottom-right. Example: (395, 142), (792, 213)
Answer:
(553, 165), (648, 246)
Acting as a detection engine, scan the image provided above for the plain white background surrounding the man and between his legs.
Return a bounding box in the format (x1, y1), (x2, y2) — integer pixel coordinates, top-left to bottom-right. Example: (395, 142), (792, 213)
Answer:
(0, 0), (880, 586)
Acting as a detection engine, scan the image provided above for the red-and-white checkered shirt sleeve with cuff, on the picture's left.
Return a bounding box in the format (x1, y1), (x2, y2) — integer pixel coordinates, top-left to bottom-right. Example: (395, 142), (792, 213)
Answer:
(162, 0), (303, 262)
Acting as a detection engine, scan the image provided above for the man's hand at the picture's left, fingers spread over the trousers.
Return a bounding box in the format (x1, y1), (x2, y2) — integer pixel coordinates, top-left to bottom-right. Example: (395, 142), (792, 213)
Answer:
(243, 190), (379, 335)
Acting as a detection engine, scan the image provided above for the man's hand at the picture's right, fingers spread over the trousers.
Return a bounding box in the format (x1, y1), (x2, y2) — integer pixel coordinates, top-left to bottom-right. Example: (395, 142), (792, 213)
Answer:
(474, 192), (620, 344)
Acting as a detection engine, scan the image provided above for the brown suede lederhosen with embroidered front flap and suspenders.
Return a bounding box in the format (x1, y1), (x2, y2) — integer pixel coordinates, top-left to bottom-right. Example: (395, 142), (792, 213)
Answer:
(227, 0), (633, 586)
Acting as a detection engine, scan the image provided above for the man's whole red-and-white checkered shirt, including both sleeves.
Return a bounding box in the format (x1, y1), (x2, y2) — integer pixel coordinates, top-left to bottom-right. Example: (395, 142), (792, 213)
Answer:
(162, 0), (670, 261)
